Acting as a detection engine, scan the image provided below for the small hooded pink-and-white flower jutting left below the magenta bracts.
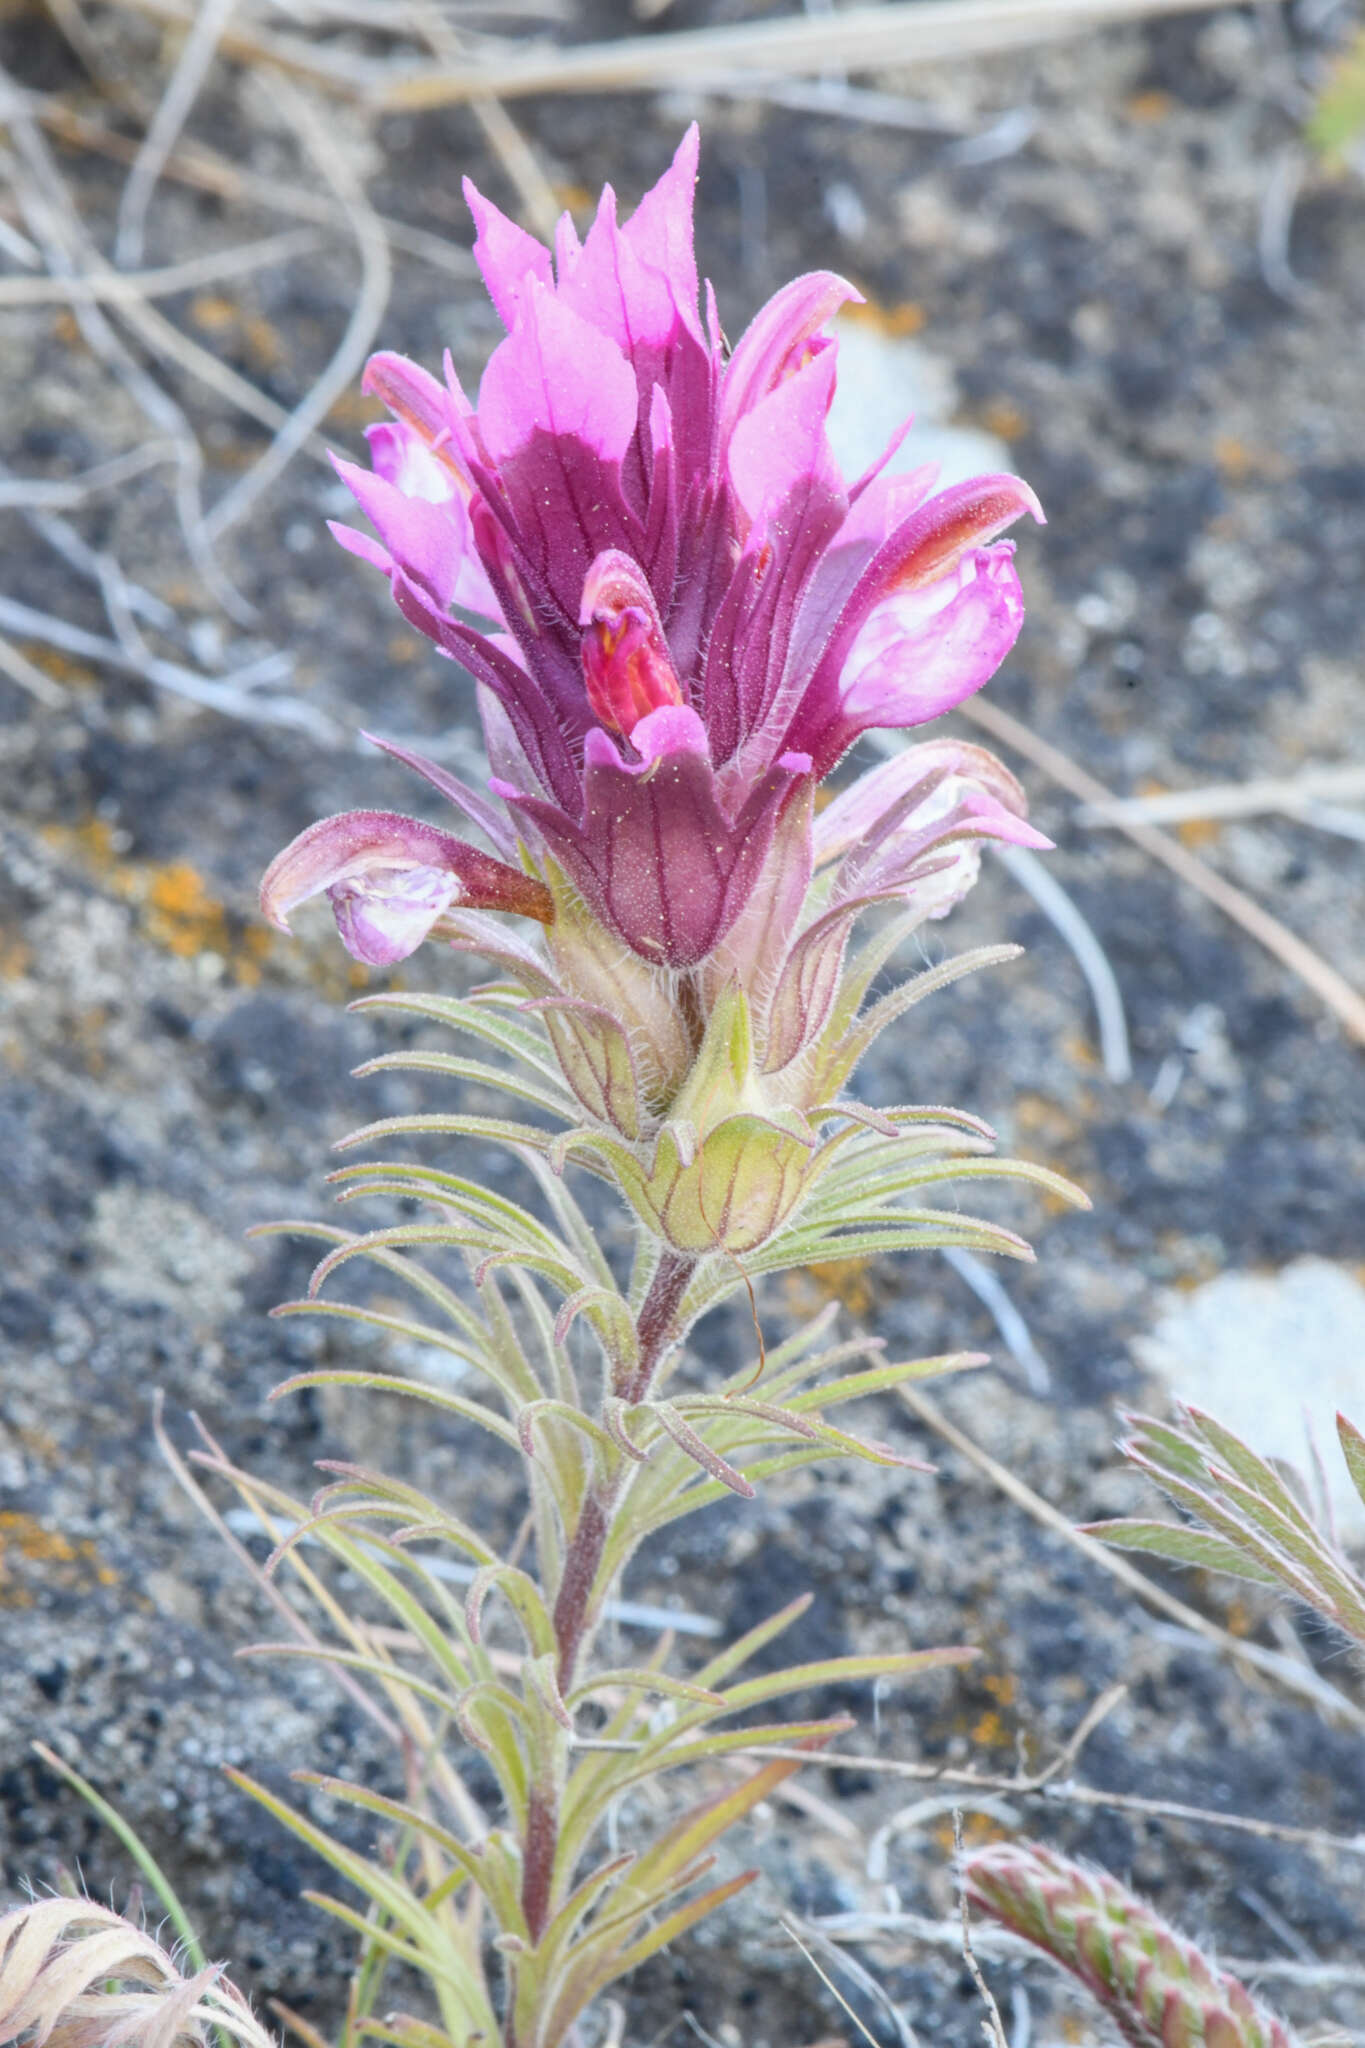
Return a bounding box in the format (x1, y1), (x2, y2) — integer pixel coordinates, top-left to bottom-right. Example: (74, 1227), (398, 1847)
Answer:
(260, 811), (555, 967)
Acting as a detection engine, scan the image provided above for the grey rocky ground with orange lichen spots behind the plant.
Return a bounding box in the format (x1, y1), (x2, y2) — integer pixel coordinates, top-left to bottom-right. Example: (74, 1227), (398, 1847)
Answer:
(0, 0), (1365, 2048)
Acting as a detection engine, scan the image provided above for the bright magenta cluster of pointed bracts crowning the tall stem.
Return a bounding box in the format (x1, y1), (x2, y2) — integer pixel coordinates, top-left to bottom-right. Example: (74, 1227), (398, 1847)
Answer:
(304, 129), (1042, 967)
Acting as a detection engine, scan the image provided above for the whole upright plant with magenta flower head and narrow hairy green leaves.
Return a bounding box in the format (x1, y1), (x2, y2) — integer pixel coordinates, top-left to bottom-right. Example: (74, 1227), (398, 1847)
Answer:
(29, 131), (1076, 2048)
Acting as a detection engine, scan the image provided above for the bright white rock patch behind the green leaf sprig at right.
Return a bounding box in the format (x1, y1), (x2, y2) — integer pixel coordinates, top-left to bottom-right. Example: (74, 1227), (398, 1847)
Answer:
(1134, 1257), (1365, 1546)
